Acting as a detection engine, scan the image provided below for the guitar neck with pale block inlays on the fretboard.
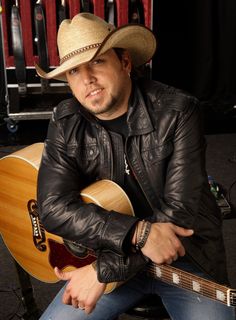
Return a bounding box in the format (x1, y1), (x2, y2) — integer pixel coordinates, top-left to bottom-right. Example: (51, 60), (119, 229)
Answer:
(148, 263), (236, 306)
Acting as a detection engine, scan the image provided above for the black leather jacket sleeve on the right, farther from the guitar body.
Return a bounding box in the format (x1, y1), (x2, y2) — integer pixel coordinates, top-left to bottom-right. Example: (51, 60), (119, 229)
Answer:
(152, 97), (207, 228)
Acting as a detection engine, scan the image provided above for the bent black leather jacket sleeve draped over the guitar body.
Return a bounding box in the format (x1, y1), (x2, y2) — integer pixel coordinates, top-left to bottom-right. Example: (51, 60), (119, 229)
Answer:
(37, 106), (137, 254)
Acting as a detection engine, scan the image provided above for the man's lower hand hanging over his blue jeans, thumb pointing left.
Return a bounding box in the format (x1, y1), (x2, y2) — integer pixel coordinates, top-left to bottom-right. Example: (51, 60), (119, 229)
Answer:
(54, 265), (106, 314)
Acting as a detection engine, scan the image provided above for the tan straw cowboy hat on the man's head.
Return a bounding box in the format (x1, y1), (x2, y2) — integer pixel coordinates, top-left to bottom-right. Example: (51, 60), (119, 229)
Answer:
(35, 13), (156, 81)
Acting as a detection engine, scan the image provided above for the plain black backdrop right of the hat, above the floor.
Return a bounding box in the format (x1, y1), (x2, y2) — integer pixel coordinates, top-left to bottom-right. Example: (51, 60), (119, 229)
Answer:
(153, 0), (236, 133)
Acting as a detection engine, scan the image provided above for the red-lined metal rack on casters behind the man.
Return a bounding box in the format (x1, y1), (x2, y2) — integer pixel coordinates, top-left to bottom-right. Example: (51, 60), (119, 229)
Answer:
(0, 0), (152, 132)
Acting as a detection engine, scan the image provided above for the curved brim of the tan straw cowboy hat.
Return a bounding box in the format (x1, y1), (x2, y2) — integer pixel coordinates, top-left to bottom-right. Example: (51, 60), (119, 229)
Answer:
(35, 24), (156, 81)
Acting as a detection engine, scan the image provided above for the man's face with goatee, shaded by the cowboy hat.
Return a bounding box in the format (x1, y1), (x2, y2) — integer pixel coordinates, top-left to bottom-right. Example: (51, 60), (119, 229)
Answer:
(66, 49), (131, 120)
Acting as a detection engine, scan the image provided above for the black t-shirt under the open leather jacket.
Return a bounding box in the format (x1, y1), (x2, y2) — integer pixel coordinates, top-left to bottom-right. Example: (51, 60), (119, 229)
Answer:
(99, 113), (152, 218)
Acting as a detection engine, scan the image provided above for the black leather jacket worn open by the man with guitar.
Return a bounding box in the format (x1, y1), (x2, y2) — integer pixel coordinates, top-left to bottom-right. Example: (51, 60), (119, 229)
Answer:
(38, 80), (227, 282)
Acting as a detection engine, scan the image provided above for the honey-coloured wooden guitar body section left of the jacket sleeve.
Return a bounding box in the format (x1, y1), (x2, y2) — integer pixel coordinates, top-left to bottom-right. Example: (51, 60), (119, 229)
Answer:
(0, 143), (58, 282)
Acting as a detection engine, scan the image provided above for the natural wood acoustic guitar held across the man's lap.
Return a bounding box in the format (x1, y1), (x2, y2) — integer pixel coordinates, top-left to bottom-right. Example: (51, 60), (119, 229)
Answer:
(0, 143), (236, 306)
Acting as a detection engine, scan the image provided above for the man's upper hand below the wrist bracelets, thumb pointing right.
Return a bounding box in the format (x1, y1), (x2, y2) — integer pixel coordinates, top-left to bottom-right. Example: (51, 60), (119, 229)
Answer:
(137, 223), (193, 264)
